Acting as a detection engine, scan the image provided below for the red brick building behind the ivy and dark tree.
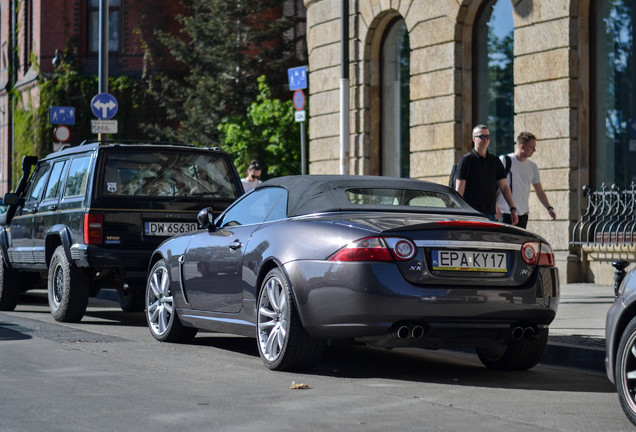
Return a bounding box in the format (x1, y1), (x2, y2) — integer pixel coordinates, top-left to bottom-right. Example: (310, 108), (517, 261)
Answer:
(0, 0), (306, 193)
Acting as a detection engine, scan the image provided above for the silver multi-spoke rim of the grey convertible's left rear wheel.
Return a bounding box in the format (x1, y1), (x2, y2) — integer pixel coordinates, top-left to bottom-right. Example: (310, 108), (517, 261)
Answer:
(257, 276), (289, 362)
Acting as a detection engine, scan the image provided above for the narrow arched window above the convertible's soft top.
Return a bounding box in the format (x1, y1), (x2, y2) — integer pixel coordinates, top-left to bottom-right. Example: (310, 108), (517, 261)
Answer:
(380, 19), (410, 177)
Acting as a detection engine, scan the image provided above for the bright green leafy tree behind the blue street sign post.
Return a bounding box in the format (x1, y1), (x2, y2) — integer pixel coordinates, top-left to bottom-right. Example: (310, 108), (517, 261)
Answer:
(218, 76), (301, 177)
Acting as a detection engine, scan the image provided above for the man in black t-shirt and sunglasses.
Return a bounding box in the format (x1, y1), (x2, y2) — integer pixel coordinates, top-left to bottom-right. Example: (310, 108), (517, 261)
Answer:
(455, 125), (519, 225)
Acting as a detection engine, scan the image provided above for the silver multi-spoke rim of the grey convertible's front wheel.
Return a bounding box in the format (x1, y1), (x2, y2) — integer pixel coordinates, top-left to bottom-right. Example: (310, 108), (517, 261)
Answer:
(146, 266), (174, 337)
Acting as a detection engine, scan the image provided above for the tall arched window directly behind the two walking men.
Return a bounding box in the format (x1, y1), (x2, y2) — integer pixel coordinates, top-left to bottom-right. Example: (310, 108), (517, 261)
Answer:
(472, 0), (515, 154)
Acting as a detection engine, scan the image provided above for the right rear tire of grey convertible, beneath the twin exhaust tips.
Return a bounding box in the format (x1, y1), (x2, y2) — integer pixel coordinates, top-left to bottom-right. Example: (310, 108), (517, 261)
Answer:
(477, 329), (548, 370)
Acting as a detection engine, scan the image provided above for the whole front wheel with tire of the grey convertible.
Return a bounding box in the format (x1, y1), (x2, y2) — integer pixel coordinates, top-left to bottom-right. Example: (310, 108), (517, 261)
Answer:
(145, 260), (198, 342)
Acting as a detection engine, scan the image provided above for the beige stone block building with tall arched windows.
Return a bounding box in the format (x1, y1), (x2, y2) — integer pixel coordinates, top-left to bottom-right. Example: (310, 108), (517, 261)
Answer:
(305, 0), (636, 284)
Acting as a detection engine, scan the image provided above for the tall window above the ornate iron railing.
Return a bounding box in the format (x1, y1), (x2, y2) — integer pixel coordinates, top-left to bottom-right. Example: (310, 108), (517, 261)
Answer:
(590, 0), (636, 188)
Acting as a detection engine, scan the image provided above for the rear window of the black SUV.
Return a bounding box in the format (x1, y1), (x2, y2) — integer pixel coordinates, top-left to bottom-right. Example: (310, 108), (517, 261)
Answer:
(100, 150), (240, 199)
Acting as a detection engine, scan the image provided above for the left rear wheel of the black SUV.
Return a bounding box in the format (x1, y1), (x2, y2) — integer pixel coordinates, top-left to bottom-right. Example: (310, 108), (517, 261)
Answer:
(48, 246), (89, 322)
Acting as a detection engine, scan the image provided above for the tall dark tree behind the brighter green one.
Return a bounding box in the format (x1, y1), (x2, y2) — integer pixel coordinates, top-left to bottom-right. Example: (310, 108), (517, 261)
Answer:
(147, 0), (298, 146)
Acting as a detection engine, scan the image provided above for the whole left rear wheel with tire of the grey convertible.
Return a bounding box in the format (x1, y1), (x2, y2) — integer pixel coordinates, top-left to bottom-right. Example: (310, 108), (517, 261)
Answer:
(256, 268), (323, 370)
